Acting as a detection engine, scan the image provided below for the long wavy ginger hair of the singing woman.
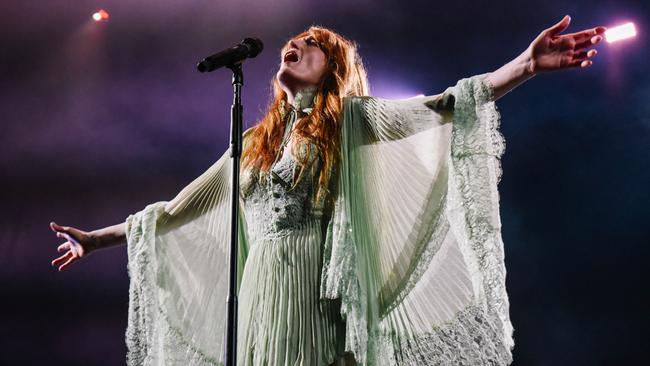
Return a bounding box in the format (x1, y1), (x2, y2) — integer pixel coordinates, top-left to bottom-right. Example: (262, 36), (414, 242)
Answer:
(242, 26), (368, 200)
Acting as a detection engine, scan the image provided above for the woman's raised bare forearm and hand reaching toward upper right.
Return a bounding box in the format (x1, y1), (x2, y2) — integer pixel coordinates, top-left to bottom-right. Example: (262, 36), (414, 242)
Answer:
(487, 15), (606, 100)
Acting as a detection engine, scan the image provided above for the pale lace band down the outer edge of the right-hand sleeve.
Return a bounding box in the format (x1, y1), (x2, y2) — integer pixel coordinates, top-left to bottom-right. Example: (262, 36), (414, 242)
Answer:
(452, 76), (514, 353)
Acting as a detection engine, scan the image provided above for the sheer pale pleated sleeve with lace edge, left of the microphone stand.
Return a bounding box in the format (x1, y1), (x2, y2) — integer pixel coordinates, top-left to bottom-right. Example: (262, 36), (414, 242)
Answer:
(126, 152), (247, 365)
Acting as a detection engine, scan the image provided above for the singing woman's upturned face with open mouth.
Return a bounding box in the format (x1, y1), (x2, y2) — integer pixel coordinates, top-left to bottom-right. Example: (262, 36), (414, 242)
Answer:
(276, 35), (327, 95)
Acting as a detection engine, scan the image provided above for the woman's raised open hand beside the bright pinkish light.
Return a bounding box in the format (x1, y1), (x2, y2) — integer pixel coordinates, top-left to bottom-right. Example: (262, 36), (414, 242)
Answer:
(527, 15), (606, 74)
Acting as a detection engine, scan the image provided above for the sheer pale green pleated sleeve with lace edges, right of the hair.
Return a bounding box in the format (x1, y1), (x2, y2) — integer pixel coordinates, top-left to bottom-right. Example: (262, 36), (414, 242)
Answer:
(321, 75), (513, 365)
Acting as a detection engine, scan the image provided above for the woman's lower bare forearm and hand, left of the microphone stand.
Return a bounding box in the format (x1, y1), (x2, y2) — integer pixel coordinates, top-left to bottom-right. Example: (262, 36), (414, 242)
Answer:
(50, 222), (126, 271)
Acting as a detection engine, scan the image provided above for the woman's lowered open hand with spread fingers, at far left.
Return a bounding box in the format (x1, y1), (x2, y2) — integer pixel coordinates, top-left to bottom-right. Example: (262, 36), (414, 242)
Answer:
(50, 222), (97, 271)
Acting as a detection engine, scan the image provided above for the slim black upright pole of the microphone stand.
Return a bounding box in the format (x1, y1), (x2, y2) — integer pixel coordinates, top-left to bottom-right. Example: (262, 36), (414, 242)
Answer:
(225, 63), (244, 366)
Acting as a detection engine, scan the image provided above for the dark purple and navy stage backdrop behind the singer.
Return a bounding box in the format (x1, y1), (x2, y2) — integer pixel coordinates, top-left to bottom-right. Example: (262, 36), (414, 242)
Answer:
(0, 0), (650, 365)
